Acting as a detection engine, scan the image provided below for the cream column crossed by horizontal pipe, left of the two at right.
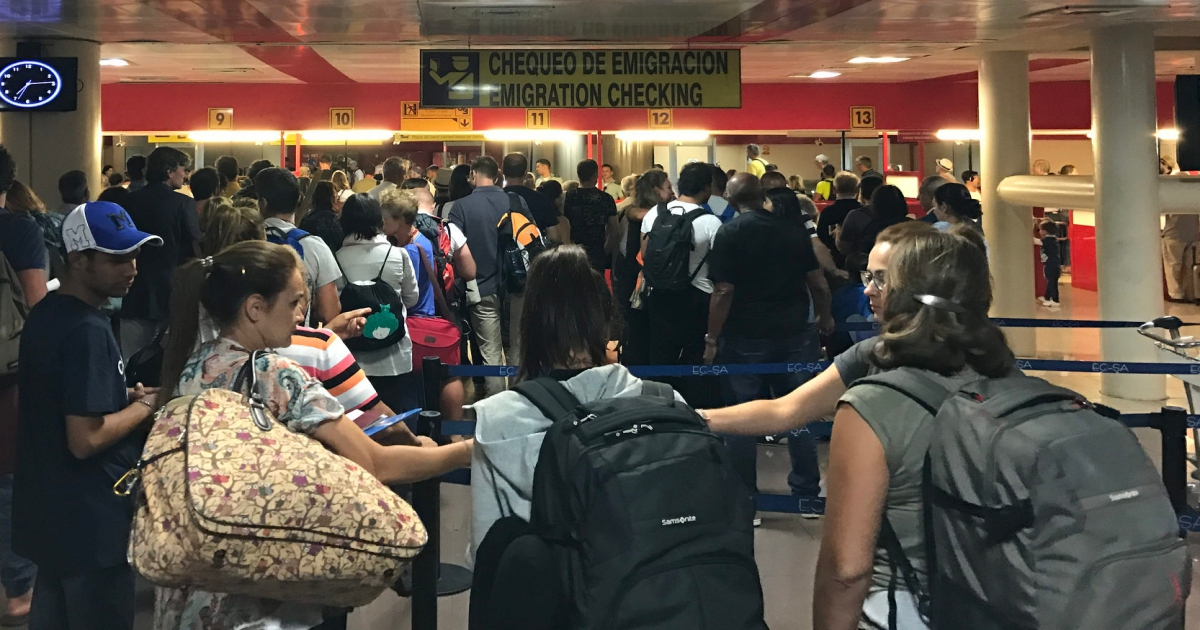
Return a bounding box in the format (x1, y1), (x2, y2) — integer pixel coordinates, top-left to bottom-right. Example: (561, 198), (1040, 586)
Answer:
(979, 52), (1036, 356)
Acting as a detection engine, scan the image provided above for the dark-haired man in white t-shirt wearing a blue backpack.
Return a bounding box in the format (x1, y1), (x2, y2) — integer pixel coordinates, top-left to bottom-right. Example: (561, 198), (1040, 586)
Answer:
(254, 167), (342, 325)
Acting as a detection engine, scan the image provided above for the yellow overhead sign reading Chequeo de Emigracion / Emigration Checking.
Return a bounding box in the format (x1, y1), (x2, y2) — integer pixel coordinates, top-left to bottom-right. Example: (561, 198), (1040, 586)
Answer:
(421, 49), (742, 109)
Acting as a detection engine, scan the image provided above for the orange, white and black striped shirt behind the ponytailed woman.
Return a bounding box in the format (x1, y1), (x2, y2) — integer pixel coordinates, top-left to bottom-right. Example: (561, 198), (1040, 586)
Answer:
(275, 326), (379, 412)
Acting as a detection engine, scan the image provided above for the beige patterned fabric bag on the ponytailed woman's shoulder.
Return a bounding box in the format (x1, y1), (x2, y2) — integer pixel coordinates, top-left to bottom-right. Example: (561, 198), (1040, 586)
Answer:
(118, 360), (427, 606)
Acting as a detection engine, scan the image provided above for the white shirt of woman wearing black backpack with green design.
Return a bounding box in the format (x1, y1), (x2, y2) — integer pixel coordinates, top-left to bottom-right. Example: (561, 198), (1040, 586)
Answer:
(337, 235), (421, 377)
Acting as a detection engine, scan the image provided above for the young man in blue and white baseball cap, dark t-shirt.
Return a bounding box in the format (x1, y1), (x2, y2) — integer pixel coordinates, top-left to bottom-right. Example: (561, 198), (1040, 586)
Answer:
(13, 202), (162, 630)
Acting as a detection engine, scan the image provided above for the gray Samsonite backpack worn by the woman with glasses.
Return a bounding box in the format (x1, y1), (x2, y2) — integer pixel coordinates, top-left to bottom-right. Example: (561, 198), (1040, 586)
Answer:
(858, 368), (1192, 630)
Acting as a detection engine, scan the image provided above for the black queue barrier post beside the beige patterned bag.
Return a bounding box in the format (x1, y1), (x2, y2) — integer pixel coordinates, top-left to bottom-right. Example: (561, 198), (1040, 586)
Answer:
(413, 356), (472, 630)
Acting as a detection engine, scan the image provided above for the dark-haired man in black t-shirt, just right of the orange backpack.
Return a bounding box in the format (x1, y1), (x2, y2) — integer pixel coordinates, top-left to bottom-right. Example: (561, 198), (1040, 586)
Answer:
(563, 160), (620, 274)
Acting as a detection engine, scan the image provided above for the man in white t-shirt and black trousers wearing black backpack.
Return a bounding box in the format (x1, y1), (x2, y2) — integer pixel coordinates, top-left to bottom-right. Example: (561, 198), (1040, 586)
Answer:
(642, 162), (721, 404)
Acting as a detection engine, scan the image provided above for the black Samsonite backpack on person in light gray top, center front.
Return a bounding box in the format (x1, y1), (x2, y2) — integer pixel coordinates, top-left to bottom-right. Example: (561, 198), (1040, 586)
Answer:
(517, 378), (767, 630)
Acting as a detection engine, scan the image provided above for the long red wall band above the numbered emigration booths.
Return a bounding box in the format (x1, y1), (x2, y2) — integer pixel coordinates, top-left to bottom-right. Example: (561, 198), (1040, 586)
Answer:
(102, 82), (1174, 132)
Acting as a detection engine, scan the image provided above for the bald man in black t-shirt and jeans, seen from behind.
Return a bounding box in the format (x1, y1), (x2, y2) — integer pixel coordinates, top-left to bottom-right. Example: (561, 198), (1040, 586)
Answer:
(704, 173), (833, 516)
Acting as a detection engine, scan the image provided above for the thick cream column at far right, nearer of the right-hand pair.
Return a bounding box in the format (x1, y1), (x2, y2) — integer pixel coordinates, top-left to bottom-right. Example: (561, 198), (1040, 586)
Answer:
(1092, 24), (1166, 401)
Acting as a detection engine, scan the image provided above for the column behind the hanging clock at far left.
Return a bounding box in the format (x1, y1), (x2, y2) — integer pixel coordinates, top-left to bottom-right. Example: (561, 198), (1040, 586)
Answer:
(0, 40), (100, 201)
